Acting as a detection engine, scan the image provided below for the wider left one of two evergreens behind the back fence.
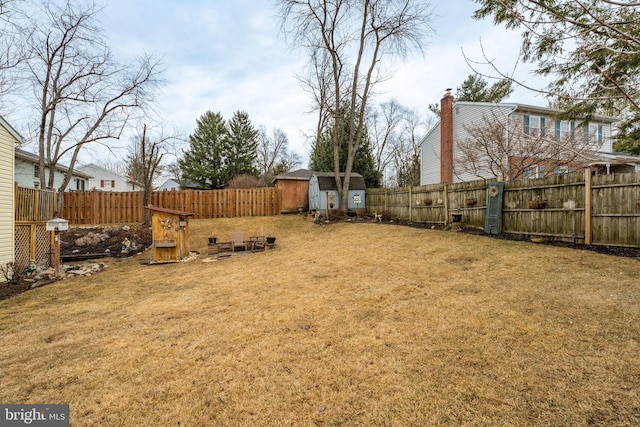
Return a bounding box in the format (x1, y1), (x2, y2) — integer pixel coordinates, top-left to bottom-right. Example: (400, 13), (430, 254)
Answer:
(179, 111), (229, 189)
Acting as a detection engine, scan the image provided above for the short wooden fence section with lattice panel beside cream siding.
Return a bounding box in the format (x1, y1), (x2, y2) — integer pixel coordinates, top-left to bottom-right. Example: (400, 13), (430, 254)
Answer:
(14, 186), (57, 271)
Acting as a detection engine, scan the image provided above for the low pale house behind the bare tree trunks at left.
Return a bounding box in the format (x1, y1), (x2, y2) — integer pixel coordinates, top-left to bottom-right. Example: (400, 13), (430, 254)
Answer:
(15, 148), (91, 191)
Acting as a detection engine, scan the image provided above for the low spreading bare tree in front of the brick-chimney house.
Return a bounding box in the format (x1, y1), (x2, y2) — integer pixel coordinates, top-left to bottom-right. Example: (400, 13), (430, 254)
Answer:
(454, 112), (596, 179)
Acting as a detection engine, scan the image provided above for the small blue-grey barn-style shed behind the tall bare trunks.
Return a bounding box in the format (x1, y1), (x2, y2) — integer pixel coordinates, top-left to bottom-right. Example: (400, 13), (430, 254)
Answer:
(309, 172), (366, 211)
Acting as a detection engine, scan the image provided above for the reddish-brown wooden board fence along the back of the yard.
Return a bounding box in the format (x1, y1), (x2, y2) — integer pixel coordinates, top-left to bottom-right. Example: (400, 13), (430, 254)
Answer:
(60, 188), (281, 224)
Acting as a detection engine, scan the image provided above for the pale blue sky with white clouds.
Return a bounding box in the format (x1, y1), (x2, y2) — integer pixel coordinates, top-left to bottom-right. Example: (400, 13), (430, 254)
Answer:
(15, 0), (546, 167)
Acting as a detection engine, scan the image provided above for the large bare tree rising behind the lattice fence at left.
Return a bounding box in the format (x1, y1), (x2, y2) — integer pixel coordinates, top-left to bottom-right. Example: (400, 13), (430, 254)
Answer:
(26, 0), (160, 206)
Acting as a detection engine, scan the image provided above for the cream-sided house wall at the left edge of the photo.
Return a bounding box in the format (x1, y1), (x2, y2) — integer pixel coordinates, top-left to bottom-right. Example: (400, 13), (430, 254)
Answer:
(0, 116), (22, 272)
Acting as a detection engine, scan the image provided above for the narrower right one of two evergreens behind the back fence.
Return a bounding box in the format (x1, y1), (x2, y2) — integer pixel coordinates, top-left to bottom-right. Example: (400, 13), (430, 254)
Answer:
(225, 111), (258, 180)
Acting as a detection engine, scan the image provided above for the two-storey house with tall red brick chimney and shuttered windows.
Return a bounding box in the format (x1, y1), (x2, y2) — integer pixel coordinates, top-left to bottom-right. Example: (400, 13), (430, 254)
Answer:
(420, 92), (640, 185)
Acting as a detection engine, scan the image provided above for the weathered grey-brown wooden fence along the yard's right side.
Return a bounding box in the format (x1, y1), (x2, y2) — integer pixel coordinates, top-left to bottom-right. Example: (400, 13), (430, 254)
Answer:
(367, 172), (640, 247)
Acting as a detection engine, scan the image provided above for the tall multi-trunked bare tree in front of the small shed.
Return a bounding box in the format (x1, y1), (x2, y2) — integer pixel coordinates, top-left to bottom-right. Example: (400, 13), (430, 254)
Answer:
(280, 0), (430, 209)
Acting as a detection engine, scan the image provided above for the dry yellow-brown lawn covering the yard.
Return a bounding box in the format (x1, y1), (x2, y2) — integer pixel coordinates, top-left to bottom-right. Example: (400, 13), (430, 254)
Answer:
(0, 216), (640, 426)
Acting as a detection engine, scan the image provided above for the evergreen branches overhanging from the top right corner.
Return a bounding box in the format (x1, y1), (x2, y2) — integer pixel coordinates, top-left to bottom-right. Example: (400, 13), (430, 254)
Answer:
(474, 0), (640, 118)
